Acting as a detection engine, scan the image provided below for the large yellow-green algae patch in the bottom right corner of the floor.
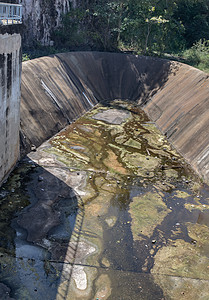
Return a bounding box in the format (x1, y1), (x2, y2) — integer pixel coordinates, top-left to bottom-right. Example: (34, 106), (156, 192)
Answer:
(151, 223), (209, 300)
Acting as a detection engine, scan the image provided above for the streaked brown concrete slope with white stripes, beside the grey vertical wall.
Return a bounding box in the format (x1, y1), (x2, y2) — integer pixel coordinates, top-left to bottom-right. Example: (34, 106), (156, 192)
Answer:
(21, 56), (97, 152)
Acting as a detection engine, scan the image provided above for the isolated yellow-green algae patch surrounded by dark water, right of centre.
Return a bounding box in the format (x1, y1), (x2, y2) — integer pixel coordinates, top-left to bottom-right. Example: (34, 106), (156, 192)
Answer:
(129, 192), (171, 240)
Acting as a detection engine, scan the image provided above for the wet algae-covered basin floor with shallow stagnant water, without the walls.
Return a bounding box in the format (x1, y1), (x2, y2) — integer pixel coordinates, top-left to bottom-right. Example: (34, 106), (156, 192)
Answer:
(0, 100), (209, 300)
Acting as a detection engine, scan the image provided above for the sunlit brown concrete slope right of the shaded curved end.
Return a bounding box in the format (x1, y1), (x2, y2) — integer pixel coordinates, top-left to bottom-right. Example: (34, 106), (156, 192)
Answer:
(145, 64), (209, 181)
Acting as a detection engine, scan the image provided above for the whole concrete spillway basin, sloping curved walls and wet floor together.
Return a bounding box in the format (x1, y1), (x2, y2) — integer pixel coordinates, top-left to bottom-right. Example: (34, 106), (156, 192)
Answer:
(0, 52), (209, 300)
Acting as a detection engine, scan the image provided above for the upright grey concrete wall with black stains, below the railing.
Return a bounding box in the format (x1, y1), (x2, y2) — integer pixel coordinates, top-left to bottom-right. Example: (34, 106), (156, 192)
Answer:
(0, 33), (21, 183)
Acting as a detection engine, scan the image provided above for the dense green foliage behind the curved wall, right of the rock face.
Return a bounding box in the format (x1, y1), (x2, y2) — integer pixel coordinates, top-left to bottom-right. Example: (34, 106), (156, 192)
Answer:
(23, 0), (209, 72)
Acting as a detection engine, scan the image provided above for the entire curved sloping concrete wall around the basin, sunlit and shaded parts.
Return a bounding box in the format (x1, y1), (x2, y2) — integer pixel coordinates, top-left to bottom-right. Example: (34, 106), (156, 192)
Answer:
(21, 52), (209, 182)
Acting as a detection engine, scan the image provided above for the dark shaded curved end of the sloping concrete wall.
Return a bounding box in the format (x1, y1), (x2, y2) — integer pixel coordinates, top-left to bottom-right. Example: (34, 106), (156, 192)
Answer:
(57, 52), (171, 104)
